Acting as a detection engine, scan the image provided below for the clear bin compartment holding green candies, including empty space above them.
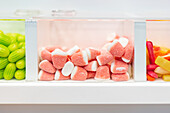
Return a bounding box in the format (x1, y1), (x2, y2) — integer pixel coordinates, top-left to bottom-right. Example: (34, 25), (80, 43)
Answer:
(0, 19), (26, 82)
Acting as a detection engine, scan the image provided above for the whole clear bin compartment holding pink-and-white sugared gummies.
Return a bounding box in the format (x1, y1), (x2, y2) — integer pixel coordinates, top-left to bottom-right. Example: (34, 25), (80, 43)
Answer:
(37, 19), (134, 82)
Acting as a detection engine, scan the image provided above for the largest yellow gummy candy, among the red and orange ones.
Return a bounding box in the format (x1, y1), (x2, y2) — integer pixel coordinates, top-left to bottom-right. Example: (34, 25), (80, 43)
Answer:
(155, 56), (170, 71)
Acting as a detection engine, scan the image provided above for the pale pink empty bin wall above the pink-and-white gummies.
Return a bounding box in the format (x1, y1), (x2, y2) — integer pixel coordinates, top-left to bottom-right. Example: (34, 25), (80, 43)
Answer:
(37, 19), (134, 82)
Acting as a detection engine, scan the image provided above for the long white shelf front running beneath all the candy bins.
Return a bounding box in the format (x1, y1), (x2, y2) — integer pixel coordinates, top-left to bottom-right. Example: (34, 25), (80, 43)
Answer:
(0, 81), (170, 104)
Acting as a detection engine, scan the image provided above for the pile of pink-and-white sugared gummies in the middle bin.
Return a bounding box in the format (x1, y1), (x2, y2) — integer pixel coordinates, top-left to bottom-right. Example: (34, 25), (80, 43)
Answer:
(39, 33), (134, 81)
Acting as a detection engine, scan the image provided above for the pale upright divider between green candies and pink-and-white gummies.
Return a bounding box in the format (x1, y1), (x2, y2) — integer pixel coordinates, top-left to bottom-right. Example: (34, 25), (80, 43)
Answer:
(25, 20), (38, 81)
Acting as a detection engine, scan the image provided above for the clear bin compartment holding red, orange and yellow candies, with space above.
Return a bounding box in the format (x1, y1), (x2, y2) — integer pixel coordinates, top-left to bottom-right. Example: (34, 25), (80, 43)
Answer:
(146, 20), (170, 81)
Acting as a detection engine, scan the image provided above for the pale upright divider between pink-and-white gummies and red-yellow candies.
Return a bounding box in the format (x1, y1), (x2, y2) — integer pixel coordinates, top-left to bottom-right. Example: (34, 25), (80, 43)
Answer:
(134, 22), (146, 82)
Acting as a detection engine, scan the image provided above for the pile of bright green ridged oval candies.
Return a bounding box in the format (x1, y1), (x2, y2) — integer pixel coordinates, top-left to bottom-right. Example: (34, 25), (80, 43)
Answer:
(0, 31), (25, 80)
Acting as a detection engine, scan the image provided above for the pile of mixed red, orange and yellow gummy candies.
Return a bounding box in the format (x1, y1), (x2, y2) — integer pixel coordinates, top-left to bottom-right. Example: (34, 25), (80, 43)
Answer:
(146, 41), (170, 81)
